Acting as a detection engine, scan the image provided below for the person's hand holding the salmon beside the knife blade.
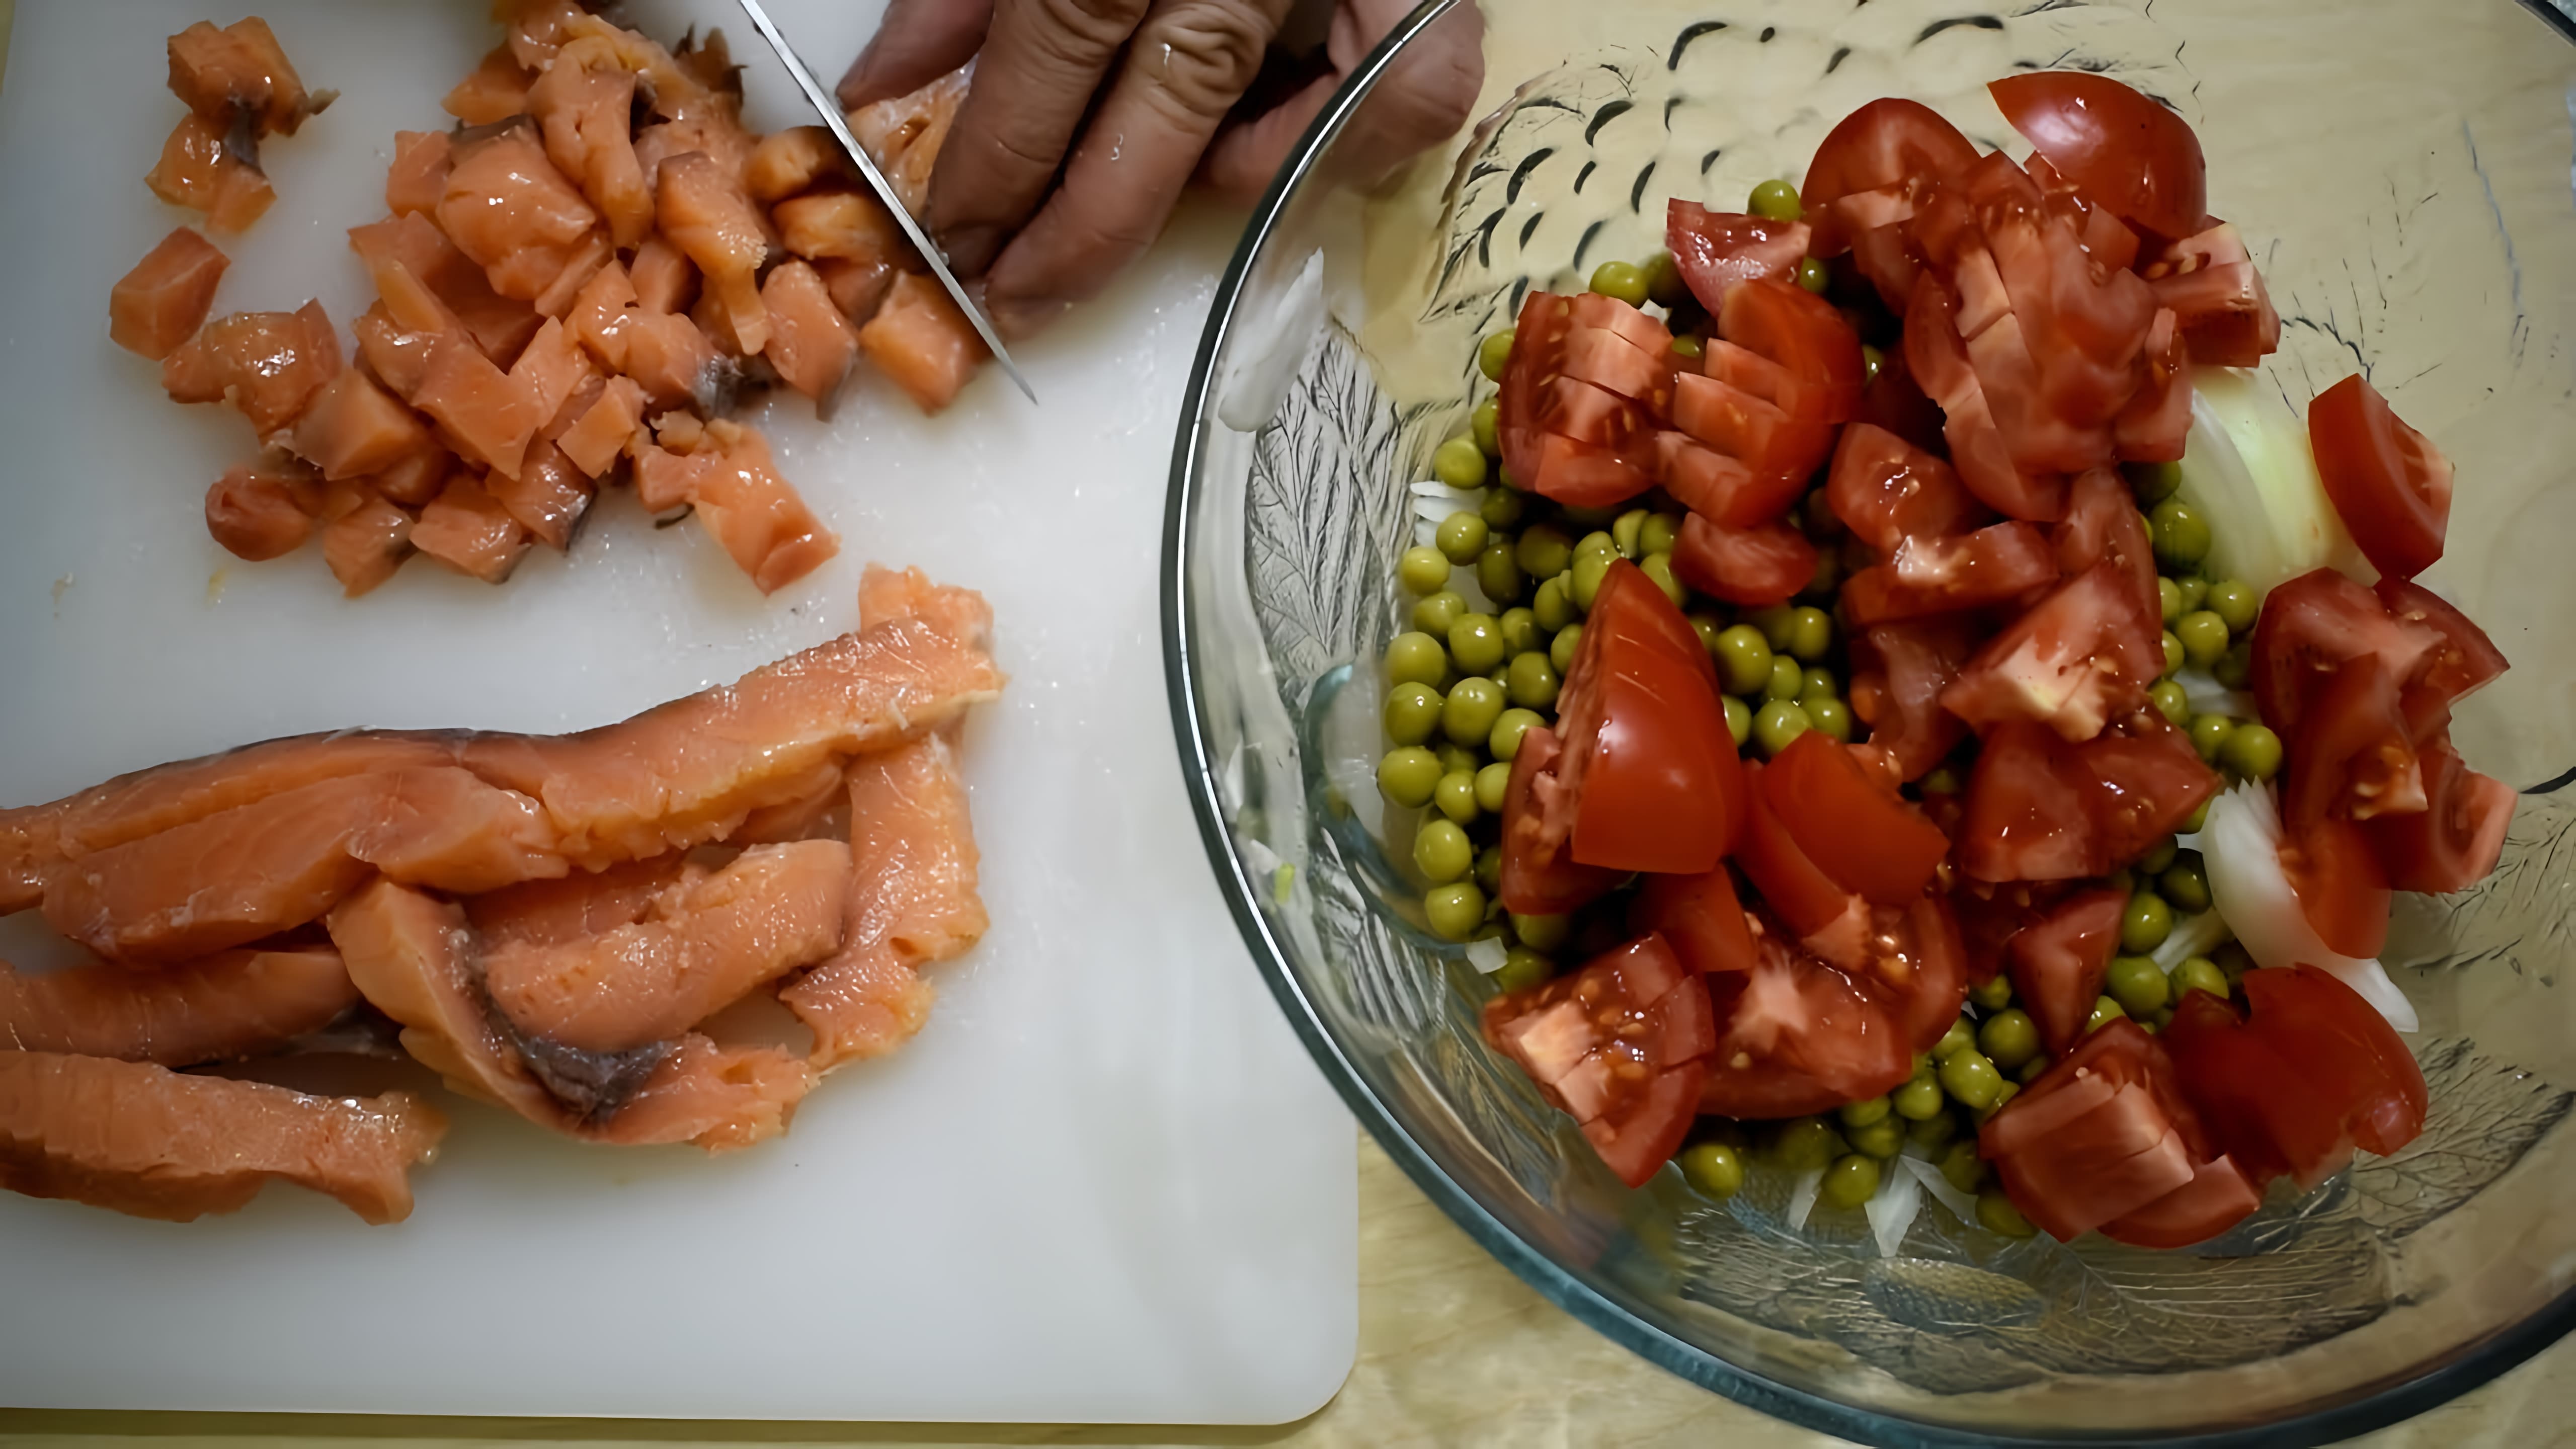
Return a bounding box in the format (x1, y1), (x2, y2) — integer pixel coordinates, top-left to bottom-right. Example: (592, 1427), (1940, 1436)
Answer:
(840, 0), (1484, 338)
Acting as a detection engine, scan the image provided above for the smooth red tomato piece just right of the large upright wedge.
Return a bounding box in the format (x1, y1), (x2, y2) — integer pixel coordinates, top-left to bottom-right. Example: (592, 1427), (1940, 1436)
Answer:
(1759, 730), (1950, 905)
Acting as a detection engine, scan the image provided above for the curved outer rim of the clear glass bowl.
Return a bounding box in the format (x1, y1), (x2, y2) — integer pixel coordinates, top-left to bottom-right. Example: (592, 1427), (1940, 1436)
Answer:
(1162, 0), (2576, 1449)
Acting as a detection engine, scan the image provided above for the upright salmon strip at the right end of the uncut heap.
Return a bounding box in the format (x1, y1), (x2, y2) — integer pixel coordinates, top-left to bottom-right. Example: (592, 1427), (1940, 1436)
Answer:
(778, 735), (989, 1070)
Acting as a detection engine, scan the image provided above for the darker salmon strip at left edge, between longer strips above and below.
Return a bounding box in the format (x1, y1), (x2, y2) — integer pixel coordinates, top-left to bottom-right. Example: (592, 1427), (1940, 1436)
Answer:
(0, 949), (358, 1068)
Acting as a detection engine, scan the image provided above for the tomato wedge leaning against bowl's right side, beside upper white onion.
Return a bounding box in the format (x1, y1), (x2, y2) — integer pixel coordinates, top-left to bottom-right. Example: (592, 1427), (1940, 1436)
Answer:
(2308, 374), (2450, 578)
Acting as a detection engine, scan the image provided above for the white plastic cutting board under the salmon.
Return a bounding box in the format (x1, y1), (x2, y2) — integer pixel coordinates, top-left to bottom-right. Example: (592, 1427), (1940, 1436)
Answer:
(0, 0), (1357, 1423)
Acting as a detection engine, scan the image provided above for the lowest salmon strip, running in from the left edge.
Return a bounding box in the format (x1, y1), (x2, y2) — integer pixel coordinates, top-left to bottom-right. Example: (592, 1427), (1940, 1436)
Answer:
(0, 1052), (448, 1222)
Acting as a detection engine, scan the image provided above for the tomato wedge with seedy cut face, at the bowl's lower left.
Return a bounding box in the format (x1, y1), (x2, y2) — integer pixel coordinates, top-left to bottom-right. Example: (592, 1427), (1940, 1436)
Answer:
(1484, 933), (1716, 1186)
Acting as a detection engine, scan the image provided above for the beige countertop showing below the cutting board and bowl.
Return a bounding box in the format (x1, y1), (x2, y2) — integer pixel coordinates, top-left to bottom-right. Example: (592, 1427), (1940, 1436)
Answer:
(0, 1137), (2576, 1449)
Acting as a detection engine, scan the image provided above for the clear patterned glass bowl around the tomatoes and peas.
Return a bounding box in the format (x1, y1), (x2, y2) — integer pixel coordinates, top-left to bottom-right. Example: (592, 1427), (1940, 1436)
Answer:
(1164, 0), (2576, 1444)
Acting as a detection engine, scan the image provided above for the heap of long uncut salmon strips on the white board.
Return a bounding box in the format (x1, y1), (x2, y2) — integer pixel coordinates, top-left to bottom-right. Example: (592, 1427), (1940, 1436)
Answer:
(0, 565), (1005, 1222)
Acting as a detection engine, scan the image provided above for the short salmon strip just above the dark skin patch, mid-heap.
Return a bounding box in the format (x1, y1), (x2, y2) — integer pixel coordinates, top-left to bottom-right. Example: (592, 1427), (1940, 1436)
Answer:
(485, 841), (850, 1052)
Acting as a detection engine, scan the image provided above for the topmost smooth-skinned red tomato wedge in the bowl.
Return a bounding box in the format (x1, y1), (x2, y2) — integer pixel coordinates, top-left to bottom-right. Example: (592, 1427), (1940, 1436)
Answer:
(1986, 69), (2208, 237)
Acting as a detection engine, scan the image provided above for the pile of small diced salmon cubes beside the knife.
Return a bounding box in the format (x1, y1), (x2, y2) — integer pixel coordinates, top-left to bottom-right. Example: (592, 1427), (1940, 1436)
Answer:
(108, 0), (987, 598)
